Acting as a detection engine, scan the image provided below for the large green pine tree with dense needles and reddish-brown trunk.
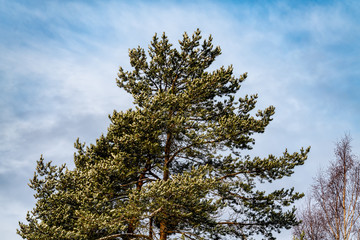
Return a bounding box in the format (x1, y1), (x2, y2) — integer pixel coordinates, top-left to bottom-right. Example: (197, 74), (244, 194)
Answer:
(18, 30), (309, 240)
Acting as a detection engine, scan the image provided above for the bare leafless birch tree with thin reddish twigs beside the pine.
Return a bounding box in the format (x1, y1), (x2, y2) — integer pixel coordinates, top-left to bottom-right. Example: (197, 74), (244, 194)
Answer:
(295, 135), (360, 240)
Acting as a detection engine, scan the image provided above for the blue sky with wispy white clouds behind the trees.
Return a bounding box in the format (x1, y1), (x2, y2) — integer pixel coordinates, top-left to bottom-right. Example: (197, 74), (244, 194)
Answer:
(0, 0), (360, 240)
